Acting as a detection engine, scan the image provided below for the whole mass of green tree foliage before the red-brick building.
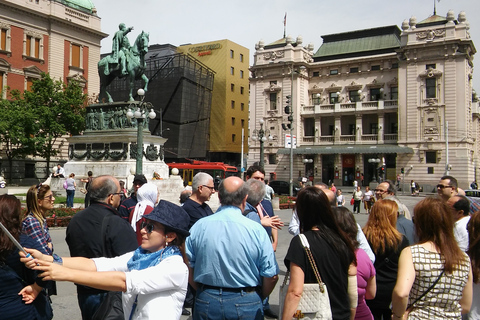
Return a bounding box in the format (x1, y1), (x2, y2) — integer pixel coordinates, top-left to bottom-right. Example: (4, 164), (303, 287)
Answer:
(0, 73), (87, 178)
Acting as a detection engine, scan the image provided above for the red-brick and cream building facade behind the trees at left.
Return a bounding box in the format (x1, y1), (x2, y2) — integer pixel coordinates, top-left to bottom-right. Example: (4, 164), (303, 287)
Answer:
(0, 0), (107, 182)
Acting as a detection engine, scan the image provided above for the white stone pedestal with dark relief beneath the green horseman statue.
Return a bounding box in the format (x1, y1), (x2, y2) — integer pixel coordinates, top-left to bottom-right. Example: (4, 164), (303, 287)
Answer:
(64, 101), (183, 195)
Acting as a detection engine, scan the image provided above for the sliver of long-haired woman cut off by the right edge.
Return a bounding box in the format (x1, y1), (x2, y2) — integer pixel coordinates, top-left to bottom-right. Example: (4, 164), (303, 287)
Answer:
(467, 211), (480, 320)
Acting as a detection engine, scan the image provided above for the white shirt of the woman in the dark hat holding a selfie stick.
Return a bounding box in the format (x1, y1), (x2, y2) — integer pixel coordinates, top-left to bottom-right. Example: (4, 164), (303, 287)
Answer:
(92, 251), (188, 320)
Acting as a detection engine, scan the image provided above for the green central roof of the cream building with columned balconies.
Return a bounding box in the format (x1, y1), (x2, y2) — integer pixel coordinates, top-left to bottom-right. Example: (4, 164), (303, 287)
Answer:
(313, 26), (400, 60)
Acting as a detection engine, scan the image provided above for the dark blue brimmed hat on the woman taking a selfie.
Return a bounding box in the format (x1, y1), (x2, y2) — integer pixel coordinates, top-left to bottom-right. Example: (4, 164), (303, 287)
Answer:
(142, 200), (190, 237)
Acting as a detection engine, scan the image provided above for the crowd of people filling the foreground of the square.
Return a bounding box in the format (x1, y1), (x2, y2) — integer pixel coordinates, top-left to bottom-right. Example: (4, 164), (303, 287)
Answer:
(0, 166), (480, 320)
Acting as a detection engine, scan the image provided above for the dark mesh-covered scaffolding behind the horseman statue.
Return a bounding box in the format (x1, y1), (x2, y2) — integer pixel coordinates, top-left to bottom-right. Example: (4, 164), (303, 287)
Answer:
(108, 52), (215, 161)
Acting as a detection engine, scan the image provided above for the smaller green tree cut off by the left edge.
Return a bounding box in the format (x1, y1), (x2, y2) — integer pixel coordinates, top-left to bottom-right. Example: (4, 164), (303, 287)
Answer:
(0, 97), (35, 183)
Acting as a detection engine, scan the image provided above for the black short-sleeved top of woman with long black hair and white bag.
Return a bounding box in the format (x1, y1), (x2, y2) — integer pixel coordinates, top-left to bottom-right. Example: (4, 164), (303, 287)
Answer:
(285, 231), (350, 320)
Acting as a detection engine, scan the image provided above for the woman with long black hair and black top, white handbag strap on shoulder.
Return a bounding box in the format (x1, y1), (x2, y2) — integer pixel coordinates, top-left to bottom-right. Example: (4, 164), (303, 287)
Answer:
(282, 187), (357, 320)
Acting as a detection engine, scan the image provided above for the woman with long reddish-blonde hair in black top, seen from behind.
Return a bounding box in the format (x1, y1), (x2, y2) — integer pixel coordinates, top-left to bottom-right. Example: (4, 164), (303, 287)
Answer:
(363, 199), (408, 320)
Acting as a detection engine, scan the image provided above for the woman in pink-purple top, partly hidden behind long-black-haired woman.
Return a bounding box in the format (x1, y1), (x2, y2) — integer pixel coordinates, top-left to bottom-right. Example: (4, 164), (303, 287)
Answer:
(334, 207), (377, 320)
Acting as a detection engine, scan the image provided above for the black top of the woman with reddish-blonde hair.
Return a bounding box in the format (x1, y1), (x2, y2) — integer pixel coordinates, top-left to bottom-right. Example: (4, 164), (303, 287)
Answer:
(367, 235), (409, 308)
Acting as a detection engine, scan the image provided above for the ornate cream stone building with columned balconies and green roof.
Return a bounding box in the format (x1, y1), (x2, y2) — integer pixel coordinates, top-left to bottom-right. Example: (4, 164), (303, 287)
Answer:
(248, 11), (480, 191)
